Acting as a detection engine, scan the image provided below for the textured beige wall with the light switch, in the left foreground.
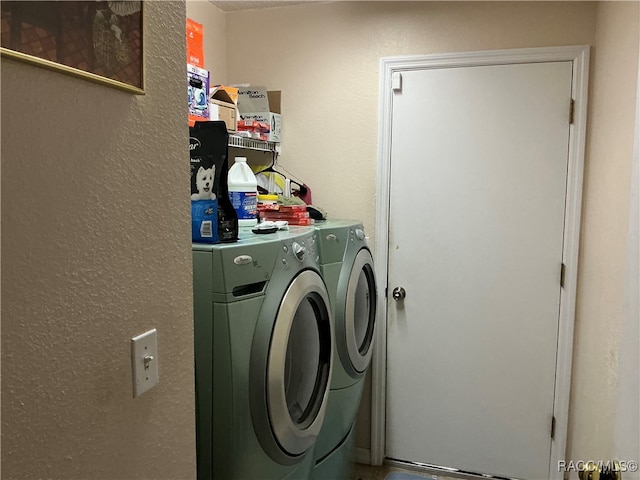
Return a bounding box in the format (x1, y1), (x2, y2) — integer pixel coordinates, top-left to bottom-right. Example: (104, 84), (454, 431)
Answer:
(2, 1), (195, 479)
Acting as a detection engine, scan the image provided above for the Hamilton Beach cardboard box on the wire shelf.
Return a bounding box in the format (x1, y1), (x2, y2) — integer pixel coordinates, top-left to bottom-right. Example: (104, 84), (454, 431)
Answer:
(238, 87), (282, 143)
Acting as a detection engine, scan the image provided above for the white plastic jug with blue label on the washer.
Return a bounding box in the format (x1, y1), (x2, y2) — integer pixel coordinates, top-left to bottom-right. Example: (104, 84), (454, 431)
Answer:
(227, 157), (258, 227)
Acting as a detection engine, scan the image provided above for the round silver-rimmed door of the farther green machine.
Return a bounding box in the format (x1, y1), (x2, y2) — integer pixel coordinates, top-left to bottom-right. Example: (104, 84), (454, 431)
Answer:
(336, 248), (376, 376)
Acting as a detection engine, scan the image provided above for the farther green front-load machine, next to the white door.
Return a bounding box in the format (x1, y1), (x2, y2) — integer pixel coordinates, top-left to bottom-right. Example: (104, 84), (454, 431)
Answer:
(313, 220), (377, 480)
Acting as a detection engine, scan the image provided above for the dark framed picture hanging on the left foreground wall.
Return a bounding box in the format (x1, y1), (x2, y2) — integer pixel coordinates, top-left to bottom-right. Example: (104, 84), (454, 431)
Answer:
(0, 0), (144, 94)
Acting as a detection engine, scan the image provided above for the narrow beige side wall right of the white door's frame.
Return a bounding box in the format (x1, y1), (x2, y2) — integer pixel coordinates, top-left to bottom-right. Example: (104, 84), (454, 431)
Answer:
(568, 2), (640, 461)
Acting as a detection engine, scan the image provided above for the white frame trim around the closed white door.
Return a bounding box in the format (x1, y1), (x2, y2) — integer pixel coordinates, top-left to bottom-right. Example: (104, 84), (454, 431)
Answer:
(371, 45), (589, 480)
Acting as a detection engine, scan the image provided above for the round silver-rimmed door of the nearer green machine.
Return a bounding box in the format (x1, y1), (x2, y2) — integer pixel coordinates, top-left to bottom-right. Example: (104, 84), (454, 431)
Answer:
(250, 270), (333, 464)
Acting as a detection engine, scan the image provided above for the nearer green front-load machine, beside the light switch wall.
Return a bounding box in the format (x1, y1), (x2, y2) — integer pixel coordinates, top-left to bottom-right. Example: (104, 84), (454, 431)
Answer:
(193, 227), (334, 480)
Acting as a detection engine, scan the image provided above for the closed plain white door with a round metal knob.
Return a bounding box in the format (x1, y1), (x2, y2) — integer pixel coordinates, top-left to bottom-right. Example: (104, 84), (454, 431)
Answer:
(386, 61), (572, 479)
